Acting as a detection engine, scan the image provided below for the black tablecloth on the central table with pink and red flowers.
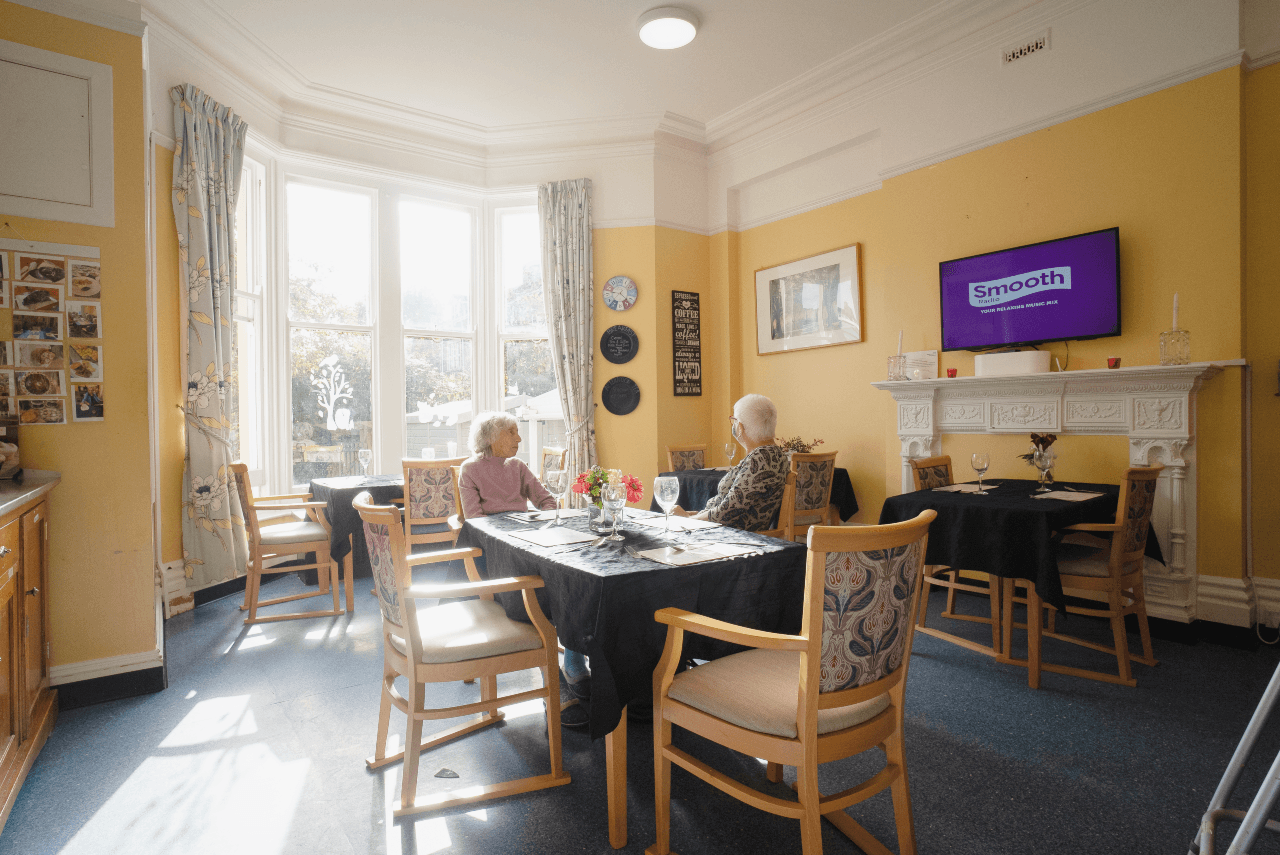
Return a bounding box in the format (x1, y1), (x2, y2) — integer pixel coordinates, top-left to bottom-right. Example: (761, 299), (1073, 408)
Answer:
(458, 509), (806, 739)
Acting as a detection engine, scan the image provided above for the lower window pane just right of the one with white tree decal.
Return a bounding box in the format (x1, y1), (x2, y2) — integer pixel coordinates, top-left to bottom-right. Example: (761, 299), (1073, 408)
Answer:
(404, 335), (471, 457)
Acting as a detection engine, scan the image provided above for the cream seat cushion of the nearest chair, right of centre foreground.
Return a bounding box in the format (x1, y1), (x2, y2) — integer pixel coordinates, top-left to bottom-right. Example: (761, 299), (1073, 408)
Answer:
(668, 650), (890, 739)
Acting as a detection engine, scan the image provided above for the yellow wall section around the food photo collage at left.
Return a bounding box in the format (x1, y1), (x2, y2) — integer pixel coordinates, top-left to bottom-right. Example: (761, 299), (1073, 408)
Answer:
(0, 0), (156, 666)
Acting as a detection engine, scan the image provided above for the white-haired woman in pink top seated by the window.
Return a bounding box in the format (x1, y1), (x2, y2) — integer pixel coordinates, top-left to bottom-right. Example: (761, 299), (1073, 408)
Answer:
(458, 412), (556, 517)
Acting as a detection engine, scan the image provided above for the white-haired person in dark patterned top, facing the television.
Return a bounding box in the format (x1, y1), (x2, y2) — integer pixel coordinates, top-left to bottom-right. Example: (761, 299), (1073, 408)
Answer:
(673, 394), (791, 531)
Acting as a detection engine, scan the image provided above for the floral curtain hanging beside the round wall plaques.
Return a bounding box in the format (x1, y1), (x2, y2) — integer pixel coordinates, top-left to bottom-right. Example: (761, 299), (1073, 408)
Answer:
(538, 178), (596, 486)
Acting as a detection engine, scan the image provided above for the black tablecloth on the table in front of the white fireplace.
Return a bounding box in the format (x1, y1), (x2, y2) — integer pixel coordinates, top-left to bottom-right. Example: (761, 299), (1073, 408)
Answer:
(879, 479), (1164, 609)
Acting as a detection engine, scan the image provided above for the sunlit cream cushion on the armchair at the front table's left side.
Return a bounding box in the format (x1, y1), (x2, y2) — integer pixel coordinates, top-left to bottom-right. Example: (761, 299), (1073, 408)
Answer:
(390, 600), (543, 664)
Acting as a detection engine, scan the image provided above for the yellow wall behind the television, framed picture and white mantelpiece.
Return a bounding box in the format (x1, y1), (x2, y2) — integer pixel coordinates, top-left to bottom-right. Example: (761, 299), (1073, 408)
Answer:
(708, 69), (1249, 577)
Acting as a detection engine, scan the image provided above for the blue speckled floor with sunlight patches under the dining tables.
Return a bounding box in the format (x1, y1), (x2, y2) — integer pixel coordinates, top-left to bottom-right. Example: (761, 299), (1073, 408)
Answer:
(0, 577), (1280, 855)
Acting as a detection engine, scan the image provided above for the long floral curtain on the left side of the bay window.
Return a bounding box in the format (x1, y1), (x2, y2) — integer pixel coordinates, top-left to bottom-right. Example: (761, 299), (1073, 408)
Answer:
(169, 83), (248, 587)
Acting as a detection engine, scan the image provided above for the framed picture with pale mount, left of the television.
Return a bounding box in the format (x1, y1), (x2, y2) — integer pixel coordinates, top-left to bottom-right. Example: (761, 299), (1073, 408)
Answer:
(755, 243), (863, 356)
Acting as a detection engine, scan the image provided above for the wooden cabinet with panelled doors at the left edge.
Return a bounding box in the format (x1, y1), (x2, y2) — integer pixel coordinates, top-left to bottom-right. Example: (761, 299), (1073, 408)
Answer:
(0, 472), (58, 829)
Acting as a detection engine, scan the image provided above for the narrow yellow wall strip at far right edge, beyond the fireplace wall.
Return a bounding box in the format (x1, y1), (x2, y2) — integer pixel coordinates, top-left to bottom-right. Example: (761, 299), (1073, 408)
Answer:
(1244, 65), (1280, 579)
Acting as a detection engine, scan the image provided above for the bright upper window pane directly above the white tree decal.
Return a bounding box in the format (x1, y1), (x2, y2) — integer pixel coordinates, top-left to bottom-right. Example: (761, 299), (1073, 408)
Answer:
(287, 184), (372, 324)
